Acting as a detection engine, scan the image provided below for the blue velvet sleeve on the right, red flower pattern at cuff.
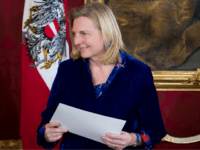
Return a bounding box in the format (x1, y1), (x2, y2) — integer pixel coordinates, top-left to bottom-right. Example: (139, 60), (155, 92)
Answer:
(137, 66), (167, 149)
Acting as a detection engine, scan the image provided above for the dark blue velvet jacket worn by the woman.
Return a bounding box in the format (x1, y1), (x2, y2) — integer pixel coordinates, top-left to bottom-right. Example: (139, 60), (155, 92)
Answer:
(37, 53), (166, 150)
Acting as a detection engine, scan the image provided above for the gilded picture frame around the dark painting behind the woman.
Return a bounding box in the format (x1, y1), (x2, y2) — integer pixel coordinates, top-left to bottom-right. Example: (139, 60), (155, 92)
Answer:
(84, 0), (200, 91)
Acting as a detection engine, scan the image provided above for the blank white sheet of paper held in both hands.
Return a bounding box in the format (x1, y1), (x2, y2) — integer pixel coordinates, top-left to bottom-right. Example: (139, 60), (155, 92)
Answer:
(50, 103), (126, 144)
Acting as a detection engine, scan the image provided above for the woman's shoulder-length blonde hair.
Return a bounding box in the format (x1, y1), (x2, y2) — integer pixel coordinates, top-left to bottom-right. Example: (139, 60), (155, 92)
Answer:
(69, 1), (125, 64)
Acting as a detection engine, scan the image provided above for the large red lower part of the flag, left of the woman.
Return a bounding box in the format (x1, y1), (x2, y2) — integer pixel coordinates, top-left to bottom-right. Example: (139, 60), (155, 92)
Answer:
(20, 45), (60, 150)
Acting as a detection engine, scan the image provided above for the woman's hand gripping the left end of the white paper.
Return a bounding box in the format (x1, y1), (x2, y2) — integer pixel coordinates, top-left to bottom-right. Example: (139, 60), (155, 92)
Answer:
(44, 122), (67, 143)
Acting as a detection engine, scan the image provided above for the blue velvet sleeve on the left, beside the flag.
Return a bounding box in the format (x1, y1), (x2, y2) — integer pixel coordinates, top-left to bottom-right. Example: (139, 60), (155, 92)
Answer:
(37, 63), (65, 150)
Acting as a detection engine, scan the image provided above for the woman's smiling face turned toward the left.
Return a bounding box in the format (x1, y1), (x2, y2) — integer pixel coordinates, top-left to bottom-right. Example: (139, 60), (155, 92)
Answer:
(72, 17), (106, 60)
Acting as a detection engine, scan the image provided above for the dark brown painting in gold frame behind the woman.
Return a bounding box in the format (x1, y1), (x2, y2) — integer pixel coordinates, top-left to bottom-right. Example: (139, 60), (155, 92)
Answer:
(85, 0), (200, 91)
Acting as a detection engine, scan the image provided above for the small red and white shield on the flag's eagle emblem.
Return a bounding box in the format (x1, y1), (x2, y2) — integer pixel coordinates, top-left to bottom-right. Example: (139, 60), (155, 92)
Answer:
(44, 18), (60, 38)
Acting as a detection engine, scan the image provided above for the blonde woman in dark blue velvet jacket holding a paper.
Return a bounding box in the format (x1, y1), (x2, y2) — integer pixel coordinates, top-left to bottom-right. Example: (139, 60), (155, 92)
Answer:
(37, 2), (166, 150)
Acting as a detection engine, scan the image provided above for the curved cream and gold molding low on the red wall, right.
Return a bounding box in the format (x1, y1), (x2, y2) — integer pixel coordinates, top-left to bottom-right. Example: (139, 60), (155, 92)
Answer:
(162, 134), (200, 144)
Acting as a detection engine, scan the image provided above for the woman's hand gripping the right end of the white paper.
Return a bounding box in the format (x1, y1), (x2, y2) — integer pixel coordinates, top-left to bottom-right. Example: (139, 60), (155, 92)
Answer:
(101, 131), (136, 150)
